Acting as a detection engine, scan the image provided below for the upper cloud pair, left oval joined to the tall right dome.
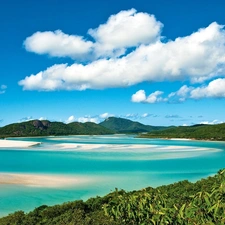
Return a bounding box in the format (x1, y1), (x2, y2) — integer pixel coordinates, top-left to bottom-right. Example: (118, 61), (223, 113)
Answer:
(24, 9), (162, 59)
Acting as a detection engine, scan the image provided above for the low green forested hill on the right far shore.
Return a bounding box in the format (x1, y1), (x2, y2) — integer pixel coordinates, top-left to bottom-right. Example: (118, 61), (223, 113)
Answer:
(141, 123), (225, 141)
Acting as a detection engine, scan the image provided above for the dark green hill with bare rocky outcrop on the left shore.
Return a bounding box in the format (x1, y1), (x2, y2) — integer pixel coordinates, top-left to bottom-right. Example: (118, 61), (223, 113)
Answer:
(0, 120), (113, 137)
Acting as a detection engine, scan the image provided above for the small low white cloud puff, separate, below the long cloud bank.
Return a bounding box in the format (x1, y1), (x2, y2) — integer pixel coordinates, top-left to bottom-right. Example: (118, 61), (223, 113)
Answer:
(131, 90), (167, 103)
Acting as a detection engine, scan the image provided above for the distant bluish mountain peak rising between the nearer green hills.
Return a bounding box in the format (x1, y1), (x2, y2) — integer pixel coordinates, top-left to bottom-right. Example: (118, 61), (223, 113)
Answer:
(100, 117), (167, 133)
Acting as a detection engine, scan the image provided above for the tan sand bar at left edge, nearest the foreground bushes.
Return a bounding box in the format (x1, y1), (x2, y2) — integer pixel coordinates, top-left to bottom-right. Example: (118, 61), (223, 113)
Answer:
(0, 173), (93, 187)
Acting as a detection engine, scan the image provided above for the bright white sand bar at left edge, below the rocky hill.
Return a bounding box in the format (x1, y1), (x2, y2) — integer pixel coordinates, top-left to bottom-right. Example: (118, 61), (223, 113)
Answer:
(0, 139), (41, 148)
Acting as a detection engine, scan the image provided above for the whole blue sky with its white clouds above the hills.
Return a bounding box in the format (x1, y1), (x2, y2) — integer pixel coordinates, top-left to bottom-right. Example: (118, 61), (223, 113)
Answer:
(0, 0), (225, 127)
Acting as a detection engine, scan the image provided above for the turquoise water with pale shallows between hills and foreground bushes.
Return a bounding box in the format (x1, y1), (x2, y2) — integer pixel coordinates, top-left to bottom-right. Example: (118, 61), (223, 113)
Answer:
(0, 135), (225, 216)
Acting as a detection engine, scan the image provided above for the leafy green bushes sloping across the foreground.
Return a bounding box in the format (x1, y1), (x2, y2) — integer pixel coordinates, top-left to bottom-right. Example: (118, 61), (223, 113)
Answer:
(0, 170), (225, 225)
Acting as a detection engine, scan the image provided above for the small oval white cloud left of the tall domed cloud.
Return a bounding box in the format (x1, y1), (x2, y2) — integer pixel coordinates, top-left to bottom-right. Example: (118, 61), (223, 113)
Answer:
(24, 30), (93, 58)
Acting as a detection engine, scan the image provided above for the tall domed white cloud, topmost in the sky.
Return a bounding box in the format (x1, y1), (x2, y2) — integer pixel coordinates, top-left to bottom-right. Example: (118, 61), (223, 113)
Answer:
(88, 9), (162, 56)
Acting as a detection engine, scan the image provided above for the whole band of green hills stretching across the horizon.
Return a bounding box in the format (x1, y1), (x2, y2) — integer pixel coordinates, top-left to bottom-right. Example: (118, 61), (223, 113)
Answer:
(0, 117), (225, 141)
